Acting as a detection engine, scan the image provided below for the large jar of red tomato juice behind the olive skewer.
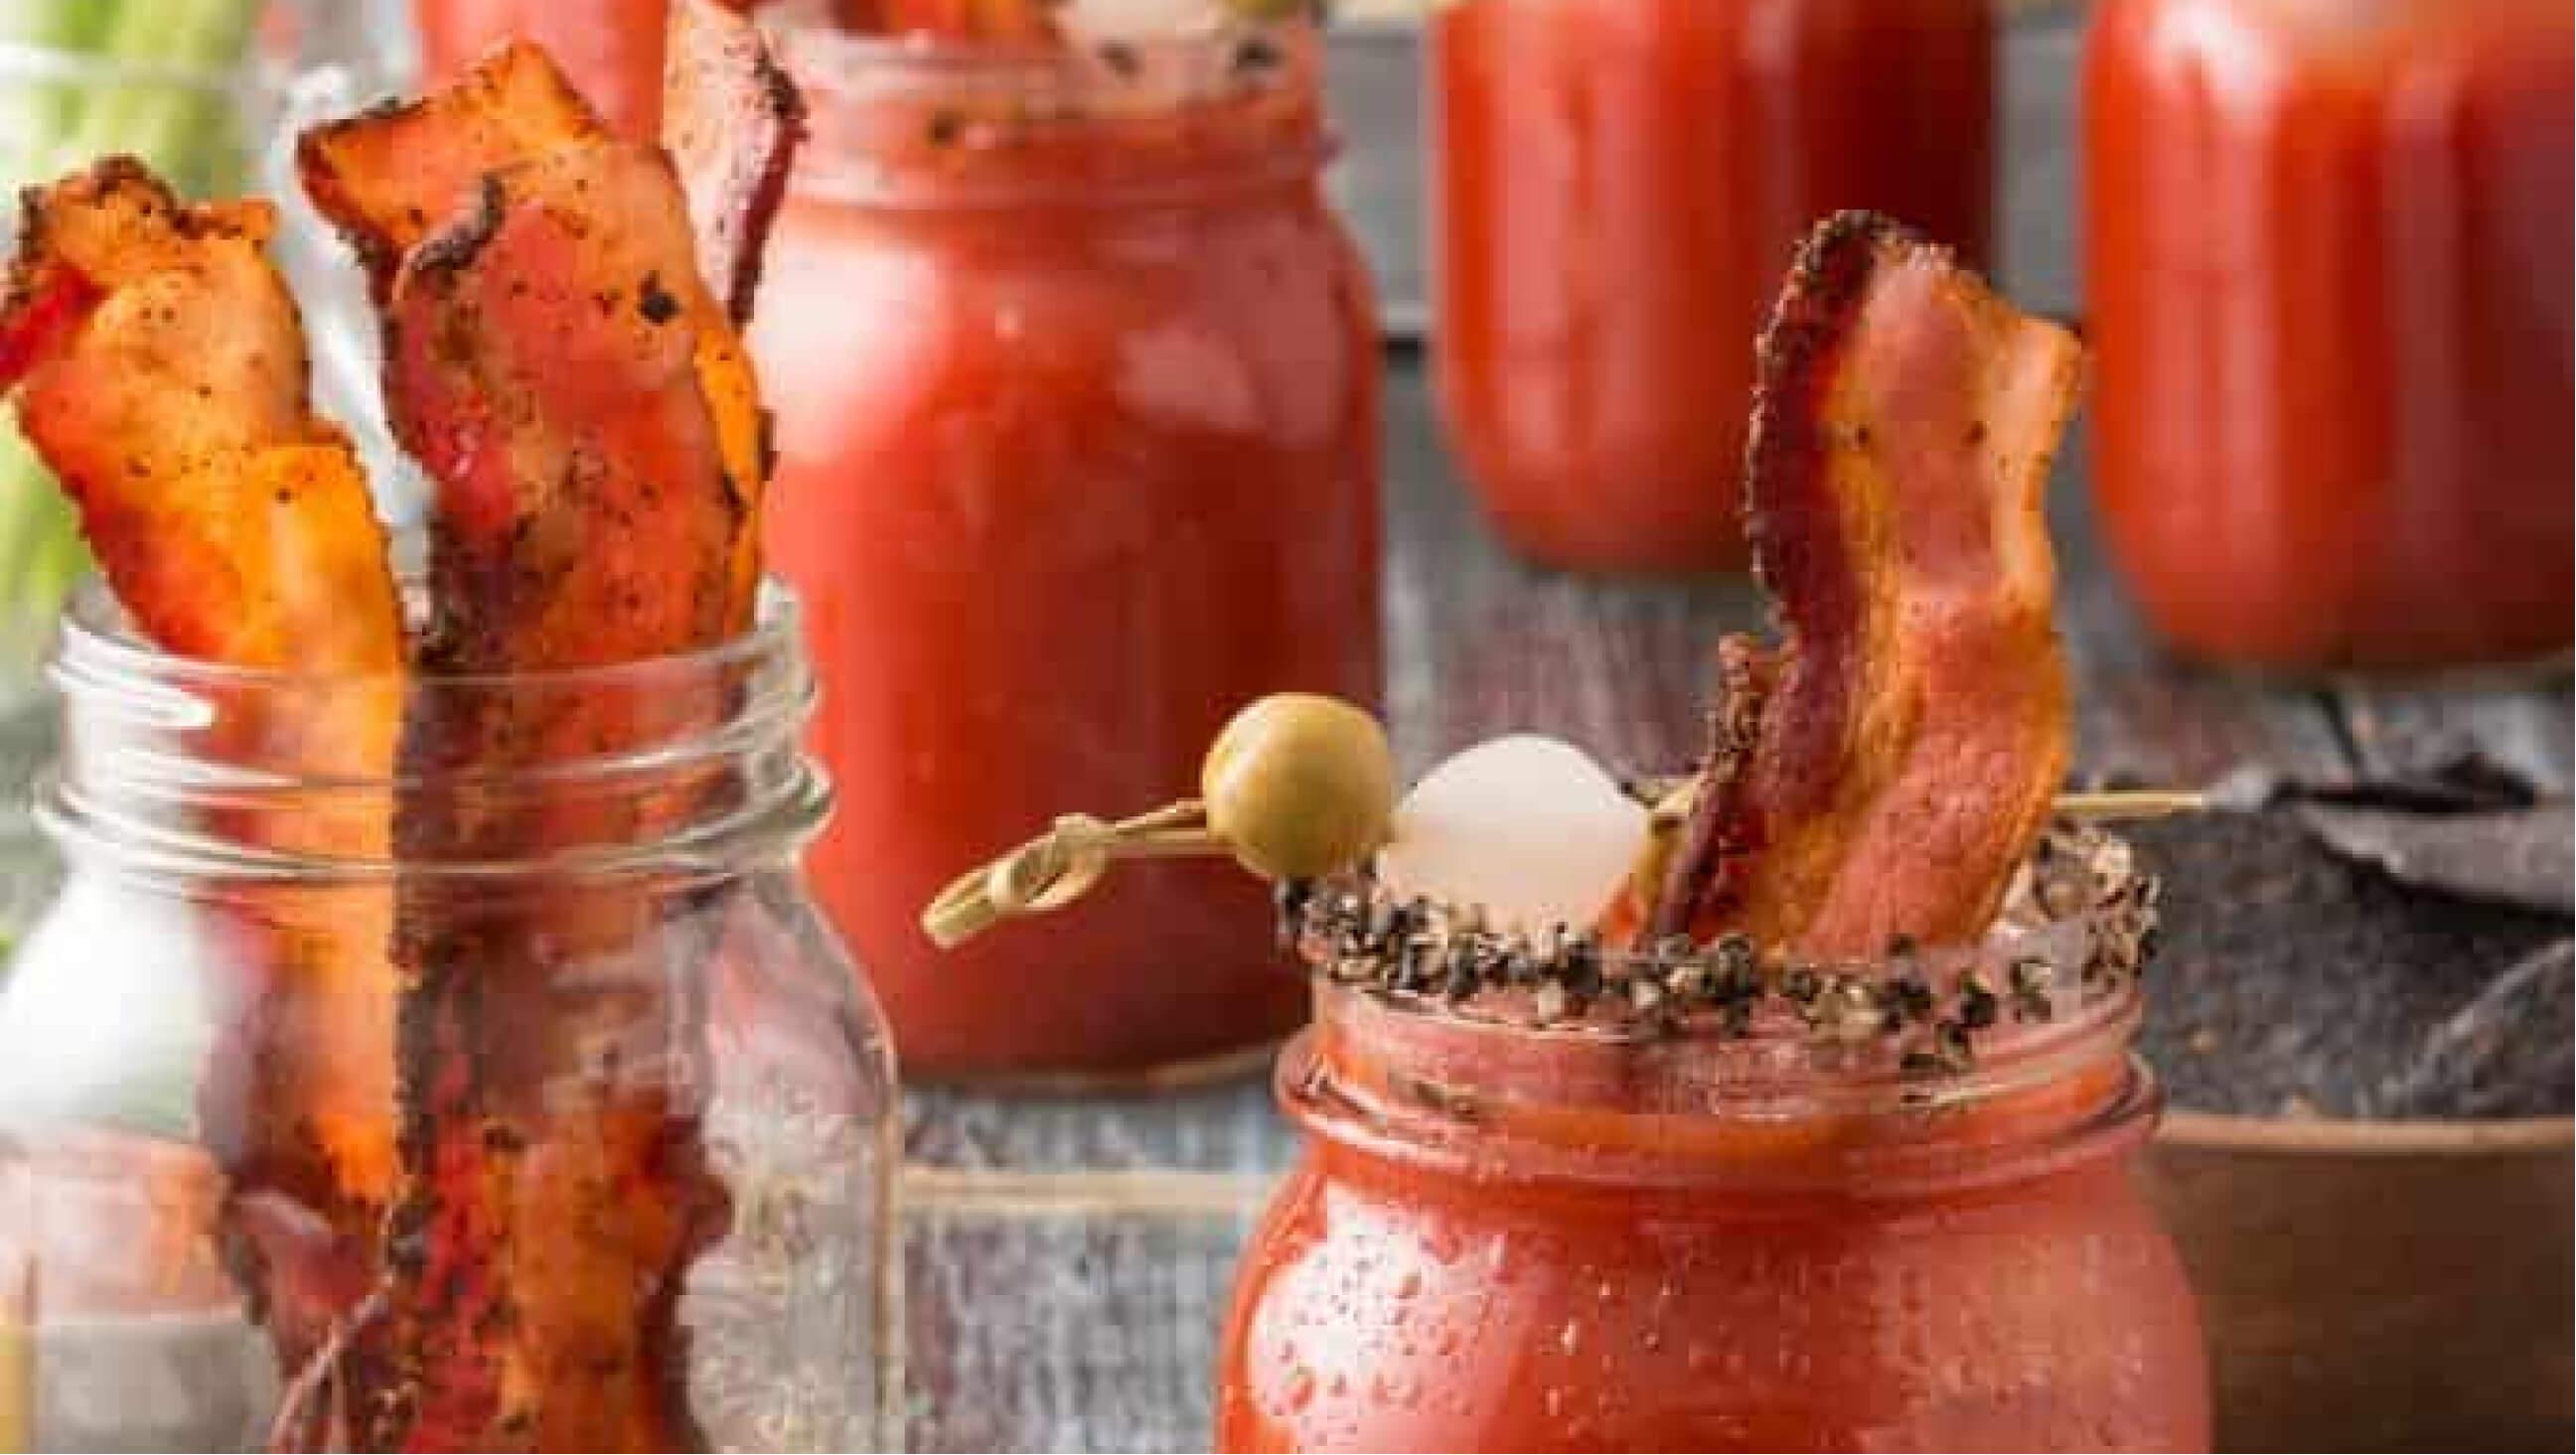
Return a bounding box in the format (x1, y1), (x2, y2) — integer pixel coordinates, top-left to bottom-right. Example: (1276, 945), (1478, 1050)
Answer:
(752, 26), (1381, 1077)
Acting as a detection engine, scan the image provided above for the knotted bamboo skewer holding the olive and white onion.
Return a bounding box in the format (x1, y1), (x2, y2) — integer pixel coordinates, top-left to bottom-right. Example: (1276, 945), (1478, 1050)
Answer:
(922, 788), (2210, 950)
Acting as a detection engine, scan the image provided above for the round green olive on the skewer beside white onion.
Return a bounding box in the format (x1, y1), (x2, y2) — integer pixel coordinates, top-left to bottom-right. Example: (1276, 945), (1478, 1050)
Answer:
(1198, 692), (1396, 878)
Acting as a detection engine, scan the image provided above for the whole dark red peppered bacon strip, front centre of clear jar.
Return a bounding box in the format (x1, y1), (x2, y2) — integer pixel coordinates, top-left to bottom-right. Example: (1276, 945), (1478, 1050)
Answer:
(327, 139), (747, 1450)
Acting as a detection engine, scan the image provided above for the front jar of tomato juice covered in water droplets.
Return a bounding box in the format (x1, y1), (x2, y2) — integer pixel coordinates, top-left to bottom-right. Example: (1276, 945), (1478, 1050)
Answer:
(1218, 880), (2210, 1450)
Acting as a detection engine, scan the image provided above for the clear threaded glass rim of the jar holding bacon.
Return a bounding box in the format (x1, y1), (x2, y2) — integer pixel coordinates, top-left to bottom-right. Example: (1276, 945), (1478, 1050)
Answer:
(36, 566), (833, 883)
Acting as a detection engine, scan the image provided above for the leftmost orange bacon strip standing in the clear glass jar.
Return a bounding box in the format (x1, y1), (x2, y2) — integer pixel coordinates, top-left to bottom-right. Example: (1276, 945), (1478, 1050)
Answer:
(0, 160), (402, 1363)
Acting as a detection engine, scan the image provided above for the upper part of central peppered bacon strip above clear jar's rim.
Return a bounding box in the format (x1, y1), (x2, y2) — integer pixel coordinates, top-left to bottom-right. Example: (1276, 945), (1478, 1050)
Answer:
(383, 142), (742, 672)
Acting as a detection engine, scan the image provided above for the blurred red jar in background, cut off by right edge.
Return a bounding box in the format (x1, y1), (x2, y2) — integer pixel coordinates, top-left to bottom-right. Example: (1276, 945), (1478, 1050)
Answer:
(2084, 0), (2576, 669)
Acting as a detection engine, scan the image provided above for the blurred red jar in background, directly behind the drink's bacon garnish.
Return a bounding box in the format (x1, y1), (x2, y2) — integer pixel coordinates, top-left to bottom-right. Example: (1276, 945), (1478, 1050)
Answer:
(1430, 0), (1994, 572)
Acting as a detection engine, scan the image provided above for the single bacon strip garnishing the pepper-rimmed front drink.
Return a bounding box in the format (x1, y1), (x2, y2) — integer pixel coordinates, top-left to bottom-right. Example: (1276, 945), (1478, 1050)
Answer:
(1656, 214), (2081, 955)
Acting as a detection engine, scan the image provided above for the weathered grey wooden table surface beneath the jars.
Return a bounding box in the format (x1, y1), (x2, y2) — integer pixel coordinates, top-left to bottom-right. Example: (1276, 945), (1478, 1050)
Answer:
(907, 351), (2571, 1450)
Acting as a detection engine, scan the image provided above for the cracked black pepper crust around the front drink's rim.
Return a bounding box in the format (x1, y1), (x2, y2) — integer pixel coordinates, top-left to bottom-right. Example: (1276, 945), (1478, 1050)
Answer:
(1278, 821), (2162, 1072)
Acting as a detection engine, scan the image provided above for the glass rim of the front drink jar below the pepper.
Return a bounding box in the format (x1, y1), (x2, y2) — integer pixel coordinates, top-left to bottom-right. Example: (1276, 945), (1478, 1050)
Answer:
(1276, 967), (2164, 1198)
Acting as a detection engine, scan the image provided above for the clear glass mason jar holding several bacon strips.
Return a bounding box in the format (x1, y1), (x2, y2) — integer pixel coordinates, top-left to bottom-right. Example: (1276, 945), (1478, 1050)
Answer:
(0, 576), (899, 1450)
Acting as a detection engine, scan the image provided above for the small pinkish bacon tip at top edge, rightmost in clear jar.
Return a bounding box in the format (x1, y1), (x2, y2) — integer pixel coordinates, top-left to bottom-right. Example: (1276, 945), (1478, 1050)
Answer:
(662, 0), (807, 330)
